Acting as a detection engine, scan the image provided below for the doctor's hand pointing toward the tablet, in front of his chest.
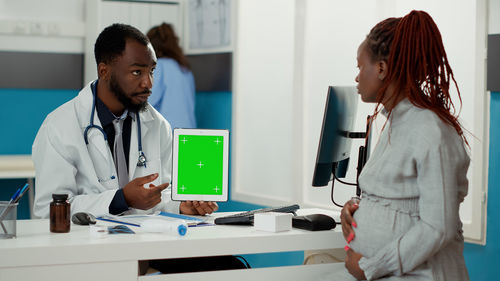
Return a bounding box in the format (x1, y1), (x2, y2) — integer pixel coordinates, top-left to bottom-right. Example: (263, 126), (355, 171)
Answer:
(123, 173), (168, 210)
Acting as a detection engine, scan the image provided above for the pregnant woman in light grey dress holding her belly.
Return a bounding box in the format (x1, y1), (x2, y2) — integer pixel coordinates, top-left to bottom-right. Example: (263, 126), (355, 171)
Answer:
(329, 11), (469, 281)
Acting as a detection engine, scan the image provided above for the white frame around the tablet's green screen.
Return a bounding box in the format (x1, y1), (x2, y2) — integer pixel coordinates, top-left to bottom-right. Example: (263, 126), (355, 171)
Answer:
(171, 128), (229, 202)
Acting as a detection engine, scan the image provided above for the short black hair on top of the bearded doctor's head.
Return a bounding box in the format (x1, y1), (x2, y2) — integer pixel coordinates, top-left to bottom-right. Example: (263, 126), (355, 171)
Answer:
(94, 23), (150, 65)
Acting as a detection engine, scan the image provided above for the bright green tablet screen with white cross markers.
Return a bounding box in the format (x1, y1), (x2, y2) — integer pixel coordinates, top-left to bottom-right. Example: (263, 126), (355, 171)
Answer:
(177, 135), (224, 195)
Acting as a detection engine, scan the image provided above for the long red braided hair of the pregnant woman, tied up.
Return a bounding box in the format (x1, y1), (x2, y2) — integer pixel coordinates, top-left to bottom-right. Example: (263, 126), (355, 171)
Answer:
(366, 11), (468, 144)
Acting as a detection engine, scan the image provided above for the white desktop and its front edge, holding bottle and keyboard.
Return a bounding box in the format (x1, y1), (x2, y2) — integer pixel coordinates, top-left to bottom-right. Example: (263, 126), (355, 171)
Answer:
(0, 210), (345, 267)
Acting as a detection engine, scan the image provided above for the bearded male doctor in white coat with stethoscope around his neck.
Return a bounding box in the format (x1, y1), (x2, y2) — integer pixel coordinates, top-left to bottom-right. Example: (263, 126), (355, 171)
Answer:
(32, 24), (218, 218)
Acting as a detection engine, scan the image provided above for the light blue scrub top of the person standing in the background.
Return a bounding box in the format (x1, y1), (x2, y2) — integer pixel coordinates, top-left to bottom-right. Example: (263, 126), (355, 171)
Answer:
(149, 58), (196, 129)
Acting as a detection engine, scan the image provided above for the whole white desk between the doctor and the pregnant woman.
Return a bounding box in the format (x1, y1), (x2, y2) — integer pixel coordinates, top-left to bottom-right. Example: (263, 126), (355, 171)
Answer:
(0, 210), (345, 281)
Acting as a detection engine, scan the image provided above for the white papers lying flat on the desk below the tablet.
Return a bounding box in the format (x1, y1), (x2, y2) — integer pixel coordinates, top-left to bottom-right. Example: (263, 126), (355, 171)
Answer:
(97, 212), (206, 227)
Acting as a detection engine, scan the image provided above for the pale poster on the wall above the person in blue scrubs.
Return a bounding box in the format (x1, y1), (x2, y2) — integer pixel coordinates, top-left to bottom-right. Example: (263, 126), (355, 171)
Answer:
(185, 0), (232, 54)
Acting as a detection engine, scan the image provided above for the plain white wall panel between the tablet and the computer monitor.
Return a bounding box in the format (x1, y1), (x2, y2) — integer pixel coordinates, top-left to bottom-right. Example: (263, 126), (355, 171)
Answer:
(231, 0), (300, 205)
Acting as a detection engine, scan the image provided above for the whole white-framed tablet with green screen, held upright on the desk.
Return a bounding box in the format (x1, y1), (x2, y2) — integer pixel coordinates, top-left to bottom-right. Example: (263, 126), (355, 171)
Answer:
(172, 129), (229, 202)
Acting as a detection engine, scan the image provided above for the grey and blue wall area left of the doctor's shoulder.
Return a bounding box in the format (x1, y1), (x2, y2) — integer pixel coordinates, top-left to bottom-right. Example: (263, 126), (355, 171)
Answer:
(0, 50), (83, 219)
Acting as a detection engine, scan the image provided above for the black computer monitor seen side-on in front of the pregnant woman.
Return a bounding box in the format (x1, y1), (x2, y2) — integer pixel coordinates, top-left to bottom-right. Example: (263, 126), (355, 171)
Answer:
(312, 86), (364, 186)
